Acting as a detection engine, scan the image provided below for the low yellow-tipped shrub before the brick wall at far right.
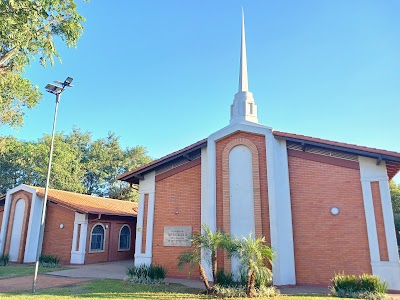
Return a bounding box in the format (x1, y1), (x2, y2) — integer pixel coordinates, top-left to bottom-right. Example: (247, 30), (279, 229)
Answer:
(331, 274), (387, 299)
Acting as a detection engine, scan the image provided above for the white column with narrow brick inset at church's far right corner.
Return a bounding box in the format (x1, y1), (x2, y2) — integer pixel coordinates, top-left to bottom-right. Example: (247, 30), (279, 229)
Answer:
(358, 156), (400, 290)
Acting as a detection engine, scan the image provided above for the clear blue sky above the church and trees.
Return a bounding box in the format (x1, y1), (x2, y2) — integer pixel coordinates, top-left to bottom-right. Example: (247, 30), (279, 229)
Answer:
(0, 0), (400, 180)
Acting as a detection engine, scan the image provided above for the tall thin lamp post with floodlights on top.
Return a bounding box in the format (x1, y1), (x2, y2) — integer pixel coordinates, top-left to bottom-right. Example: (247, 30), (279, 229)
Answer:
(32, 77), (73, 293)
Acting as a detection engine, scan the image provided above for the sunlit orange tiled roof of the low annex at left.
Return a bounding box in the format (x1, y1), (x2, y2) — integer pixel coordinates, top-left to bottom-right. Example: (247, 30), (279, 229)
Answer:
(31, 186), (138, 216)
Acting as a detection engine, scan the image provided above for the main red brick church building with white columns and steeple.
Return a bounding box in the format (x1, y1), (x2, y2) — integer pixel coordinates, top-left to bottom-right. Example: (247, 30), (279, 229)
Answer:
(118, 12), (400, 290)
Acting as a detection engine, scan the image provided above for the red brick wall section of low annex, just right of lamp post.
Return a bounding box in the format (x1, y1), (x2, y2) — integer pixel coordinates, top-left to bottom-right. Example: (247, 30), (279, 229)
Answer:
(42, 202), (75, 265)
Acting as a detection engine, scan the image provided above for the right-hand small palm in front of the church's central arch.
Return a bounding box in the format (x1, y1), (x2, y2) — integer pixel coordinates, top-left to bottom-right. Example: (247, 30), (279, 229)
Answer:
(237, 234), (274, 297)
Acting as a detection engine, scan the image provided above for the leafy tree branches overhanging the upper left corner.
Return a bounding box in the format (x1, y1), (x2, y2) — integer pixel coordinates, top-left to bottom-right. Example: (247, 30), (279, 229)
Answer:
(0, 0), (85, 127)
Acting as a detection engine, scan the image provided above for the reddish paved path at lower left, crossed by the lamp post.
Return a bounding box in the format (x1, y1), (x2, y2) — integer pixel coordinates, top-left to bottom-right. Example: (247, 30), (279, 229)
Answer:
(0, 275), (89, 293)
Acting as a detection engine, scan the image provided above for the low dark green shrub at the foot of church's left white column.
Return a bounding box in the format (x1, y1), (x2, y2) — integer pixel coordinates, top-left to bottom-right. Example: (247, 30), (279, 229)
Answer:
(125, 264), (167, 284)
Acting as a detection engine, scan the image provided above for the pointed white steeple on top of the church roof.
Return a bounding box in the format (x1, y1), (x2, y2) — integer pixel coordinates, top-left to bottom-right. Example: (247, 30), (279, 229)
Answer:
(230, 8), (258, 124)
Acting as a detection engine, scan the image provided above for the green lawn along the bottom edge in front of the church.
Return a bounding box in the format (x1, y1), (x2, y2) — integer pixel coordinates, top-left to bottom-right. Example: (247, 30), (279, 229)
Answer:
(0, 279), (346, 300)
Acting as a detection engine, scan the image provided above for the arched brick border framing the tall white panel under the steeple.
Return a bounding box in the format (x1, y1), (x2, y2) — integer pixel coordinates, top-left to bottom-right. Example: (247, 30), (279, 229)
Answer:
(222, 138), (262, 270)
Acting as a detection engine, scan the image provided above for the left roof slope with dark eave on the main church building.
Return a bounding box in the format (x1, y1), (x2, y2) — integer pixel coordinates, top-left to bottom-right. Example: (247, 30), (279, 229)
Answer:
(117, 139), (207, 183)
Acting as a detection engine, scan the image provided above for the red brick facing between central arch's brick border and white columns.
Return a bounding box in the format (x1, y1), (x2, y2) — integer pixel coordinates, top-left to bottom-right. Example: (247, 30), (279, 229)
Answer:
(216, 132), (271, 272)
